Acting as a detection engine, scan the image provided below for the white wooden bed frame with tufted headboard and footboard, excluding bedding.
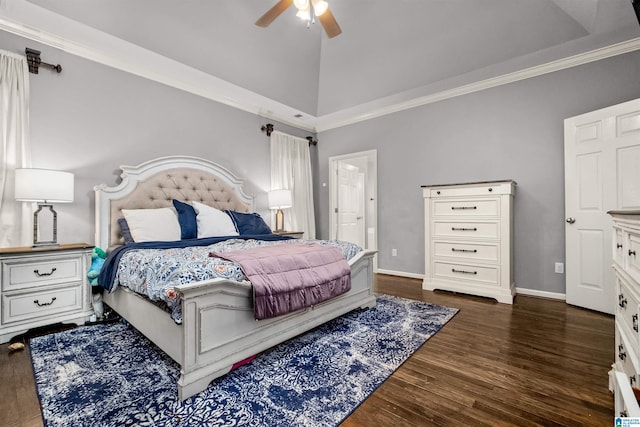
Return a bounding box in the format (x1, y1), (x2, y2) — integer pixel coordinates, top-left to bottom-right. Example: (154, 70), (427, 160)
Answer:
(94, 156), (375, 400)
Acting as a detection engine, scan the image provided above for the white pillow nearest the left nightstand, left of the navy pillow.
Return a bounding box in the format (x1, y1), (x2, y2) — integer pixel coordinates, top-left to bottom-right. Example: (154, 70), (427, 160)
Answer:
(122, 208), (181, 242)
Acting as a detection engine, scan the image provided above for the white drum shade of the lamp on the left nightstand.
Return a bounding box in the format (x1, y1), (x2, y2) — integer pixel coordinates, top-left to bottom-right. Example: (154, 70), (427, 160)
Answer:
(15, 169), (73, 203)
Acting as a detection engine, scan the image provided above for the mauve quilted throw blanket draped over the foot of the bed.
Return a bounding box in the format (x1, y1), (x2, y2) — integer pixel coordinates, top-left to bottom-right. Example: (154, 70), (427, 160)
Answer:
(209, 243), (351, 320)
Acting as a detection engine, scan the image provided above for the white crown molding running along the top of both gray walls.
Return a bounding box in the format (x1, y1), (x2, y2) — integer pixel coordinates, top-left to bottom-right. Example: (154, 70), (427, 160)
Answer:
(0, 0), (640, 133)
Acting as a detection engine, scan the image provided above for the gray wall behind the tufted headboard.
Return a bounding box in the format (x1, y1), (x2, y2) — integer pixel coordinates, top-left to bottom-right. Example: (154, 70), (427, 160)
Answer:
(0, 31), (310, 247)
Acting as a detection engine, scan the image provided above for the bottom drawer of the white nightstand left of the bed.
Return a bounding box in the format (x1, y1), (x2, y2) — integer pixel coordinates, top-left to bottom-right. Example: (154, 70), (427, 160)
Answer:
(2, 283), (83, 324)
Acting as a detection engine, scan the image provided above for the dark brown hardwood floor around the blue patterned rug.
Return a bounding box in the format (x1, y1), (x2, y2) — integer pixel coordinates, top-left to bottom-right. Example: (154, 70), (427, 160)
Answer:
(0, 275), (614, 427)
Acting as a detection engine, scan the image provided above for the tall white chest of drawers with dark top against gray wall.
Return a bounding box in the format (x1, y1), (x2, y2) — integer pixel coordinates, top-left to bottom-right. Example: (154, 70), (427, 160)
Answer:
(422, 180), (516, 304)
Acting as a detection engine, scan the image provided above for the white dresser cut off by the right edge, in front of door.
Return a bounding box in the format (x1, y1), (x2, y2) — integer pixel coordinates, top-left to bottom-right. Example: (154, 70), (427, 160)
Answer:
(609, 211), (640, 417)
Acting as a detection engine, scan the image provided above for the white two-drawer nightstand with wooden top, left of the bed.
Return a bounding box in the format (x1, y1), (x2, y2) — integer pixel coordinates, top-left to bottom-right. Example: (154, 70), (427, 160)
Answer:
(0, 243), (93, 343)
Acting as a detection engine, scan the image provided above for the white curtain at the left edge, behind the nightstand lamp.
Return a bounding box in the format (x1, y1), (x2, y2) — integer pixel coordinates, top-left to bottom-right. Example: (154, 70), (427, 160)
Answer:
(0, 49), (32, 247)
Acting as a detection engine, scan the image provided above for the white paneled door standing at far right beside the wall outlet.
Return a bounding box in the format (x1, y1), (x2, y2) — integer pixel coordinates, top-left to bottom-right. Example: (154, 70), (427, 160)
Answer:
(564, 99), (640, 314)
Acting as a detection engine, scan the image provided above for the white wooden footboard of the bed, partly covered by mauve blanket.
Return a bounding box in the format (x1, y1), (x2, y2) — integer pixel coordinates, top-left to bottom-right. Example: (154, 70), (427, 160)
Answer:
(177, 251), (375, 400)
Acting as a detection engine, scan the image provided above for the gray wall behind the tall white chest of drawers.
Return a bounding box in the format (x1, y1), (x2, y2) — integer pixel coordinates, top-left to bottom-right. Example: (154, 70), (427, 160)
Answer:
(316, 52), (640, 293)
